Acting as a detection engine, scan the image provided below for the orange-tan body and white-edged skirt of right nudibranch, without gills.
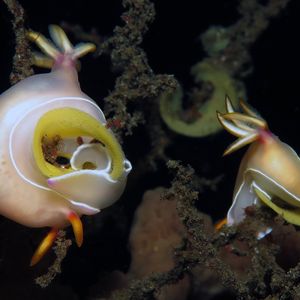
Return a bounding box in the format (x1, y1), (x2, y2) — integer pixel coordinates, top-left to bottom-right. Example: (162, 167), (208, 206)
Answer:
(227, 134), (300, 224)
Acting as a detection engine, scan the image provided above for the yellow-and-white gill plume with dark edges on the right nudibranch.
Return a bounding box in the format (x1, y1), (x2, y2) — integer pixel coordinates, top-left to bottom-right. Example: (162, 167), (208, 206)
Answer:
(217, 96), (268, 155)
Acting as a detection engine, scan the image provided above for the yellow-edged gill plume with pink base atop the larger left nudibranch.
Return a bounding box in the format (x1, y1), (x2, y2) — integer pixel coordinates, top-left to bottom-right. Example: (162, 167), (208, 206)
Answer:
(27, 25), (96, 68)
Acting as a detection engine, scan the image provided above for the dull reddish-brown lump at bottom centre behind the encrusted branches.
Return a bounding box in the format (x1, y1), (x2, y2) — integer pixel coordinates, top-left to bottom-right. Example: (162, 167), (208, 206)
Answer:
(128, 188), (189, 300)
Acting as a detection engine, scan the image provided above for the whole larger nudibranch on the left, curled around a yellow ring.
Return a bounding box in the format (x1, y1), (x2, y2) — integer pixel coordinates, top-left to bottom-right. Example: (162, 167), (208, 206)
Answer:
(0, 25), (131, 265)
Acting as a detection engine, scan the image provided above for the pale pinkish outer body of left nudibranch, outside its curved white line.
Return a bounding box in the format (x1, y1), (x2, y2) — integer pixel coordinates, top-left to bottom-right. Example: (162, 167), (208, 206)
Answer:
(0, 65), (98, 227)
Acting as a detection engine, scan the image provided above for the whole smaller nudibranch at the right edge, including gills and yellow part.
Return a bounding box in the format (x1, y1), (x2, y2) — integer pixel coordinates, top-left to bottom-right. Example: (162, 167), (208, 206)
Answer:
(217, 97), (300, 226)
